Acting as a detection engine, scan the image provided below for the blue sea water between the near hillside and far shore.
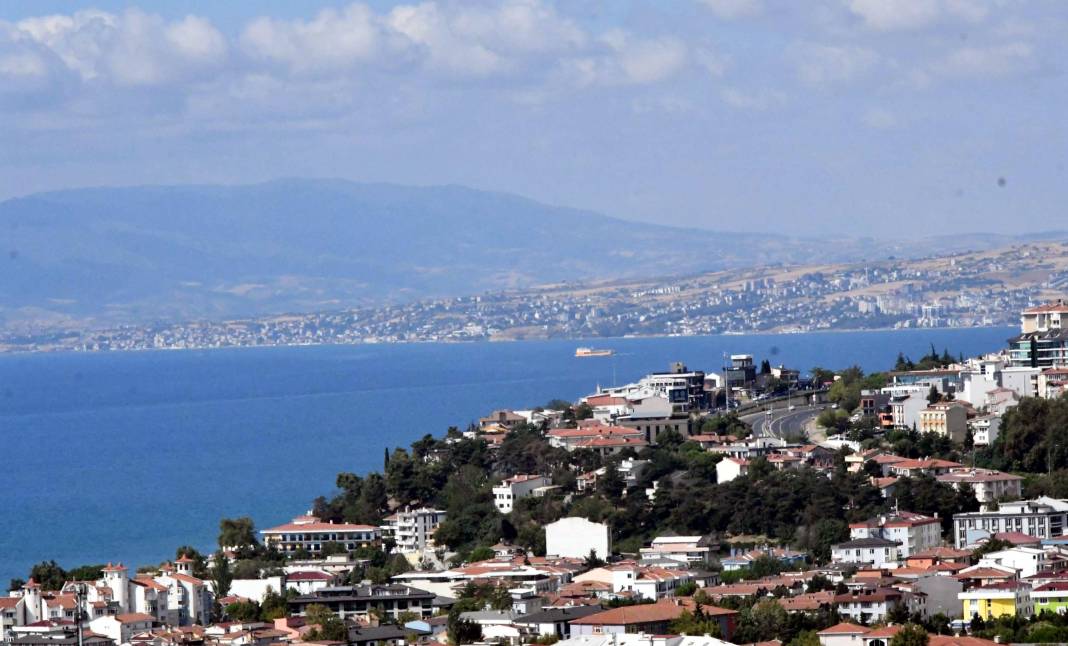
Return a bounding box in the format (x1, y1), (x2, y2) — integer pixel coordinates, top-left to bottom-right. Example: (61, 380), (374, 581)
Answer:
(0, 328), (1012, 588)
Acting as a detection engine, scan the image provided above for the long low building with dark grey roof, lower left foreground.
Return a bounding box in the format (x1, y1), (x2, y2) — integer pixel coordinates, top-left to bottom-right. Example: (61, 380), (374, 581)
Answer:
(288, 584), (435, 620)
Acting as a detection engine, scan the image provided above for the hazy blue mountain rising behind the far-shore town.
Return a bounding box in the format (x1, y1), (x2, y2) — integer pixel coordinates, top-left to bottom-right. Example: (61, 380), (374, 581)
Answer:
(0, 179), (1063, 327)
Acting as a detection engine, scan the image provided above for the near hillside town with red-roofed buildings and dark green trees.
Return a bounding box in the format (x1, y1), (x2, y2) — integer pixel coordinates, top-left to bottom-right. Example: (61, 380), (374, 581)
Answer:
(6, 300), (1068, 646)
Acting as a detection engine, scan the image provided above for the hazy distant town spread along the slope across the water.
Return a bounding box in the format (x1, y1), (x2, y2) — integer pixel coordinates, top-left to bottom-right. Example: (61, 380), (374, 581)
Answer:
(0, 242), (1068, 351)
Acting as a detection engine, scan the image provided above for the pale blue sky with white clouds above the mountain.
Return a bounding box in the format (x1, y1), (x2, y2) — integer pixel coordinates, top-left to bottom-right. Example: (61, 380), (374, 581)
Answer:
(0, 0), (1068, 238)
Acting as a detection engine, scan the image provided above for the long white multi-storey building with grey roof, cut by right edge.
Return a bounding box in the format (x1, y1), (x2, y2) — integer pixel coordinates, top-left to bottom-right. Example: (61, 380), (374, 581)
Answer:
(953, 497), (1068, 548)
